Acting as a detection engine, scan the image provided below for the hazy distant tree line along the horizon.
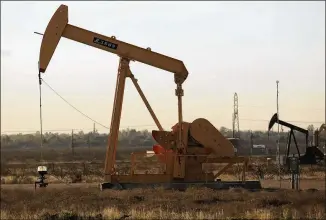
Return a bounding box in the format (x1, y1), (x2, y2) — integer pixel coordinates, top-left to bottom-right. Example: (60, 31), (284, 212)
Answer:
(1, 126), (324, 153)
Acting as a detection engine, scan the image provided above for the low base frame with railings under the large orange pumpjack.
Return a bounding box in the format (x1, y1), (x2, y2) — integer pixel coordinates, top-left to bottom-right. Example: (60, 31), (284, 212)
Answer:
(100, 155), (262, 190)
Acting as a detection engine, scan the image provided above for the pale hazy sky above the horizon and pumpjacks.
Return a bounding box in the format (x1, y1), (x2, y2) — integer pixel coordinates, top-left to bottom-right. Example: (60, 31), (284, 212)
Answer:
(1, 1), (325, 131)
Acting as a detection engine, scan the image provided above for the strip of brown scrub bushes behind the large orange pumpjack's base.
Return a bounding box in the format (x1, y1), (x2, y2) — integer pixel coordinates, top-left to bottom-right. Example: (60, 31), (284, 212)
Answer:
(1, 158), (324, 184)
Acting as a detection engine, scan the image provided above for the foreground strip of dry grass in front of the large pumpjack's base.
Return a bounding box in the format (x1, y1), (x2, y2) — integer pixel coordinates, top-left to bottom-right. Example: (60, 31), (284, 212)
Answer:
(1, 184), (326, 219)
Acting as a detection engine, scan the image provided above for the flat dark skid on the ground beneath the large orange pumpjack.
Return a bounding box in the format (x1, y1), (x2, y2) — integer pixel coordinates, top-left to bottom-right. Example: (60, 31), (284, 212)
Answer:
(100, 180), (262, 190)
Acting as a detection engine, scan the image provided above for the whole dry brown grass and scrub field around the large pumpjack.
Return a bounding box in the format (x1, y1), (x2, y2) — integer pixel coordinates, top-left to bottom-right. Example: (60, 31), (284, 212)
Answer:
(1, 149), (326, 219)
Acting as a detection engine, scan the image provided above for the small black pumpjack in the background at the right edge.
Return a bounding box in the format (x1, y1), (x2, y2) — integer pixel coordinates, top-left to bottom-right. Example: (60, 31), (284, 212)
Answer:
(268, 113), (325, 165)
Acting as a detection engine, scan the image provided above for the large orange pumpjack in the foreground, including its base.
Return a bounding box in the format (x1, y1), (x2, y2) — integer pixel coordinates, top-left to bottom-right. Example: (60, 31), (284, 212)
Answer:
(39, 5), (261, 189)
